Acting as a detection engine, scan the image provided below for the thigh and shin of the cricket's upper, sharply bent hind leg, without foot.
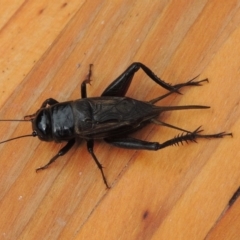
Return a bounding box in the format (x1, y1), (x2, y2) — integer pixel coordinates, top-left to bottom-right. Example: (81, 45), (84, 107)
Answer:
(101, 62), (178, 97)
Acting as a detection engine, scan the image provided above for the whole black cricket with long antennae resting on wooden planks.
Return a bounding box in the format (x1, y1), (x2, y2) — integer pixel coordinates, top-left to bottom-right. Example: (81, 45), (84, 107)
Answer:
(1, 62), (232, 188)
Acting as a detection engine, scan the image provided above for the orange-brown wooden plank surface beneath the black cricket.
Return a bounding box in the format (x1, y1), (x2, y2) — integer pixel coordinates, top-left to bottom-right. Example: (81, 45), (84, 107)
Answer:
(0, 0), (240, 240)
